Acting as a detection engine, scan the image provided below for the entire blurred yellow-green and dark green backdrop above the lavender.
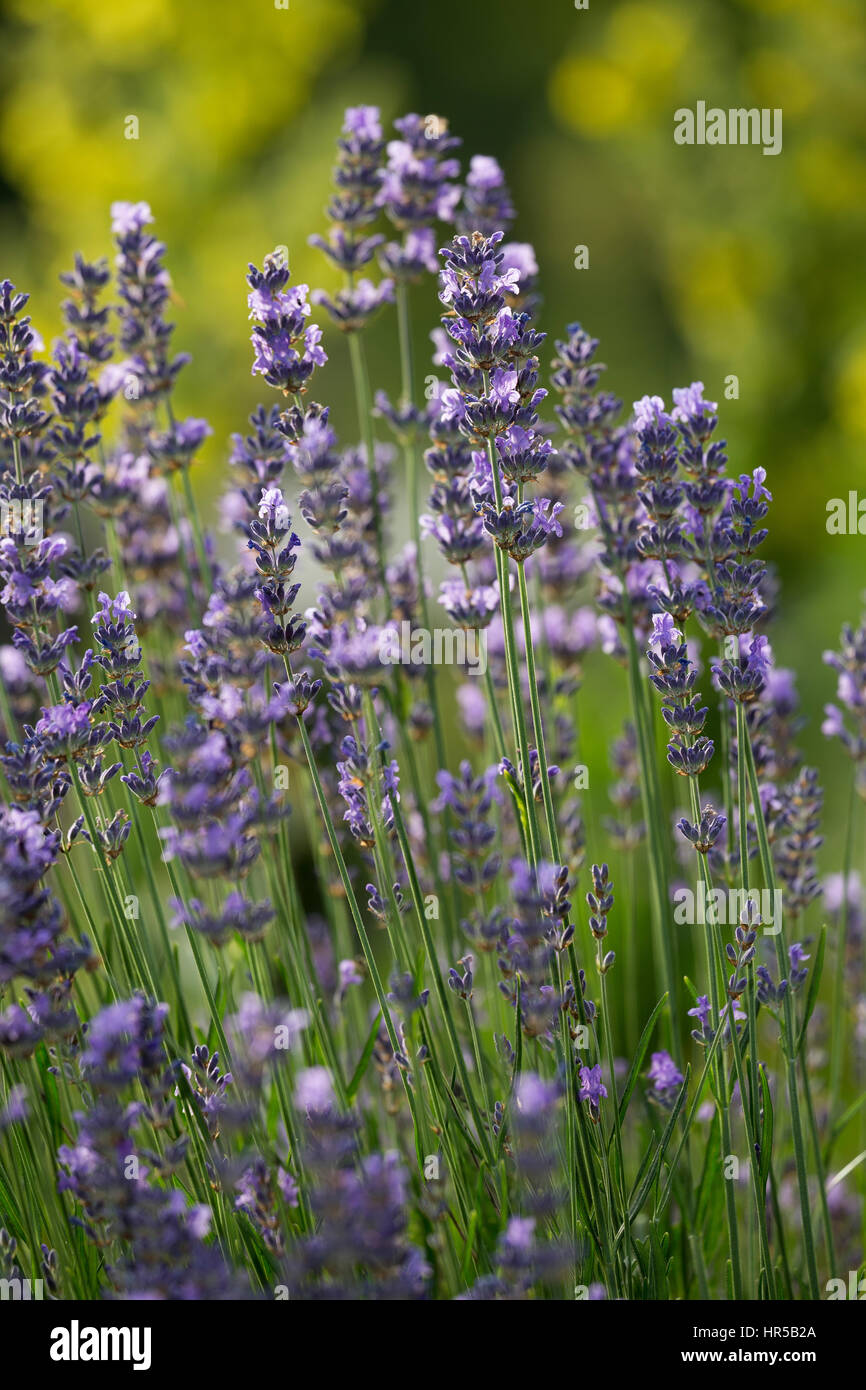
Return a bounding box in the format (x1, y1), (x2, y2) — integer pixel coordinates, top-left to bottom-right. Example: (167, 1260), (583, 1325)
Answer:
(0, 0), (866, 845)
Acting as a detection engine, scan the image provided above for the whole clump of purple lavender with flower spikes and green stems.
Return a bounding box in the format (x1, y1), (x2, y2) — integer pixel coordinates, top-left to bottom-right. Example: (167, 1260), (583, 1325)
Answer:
(0, 107), (866, 1300)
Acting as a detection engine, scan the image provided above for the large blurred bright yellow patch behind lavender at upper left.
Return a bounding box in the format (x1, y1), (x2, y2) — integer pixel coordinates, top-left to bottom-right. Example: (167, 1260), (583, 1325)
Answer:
(0, 0), (369, 489)
